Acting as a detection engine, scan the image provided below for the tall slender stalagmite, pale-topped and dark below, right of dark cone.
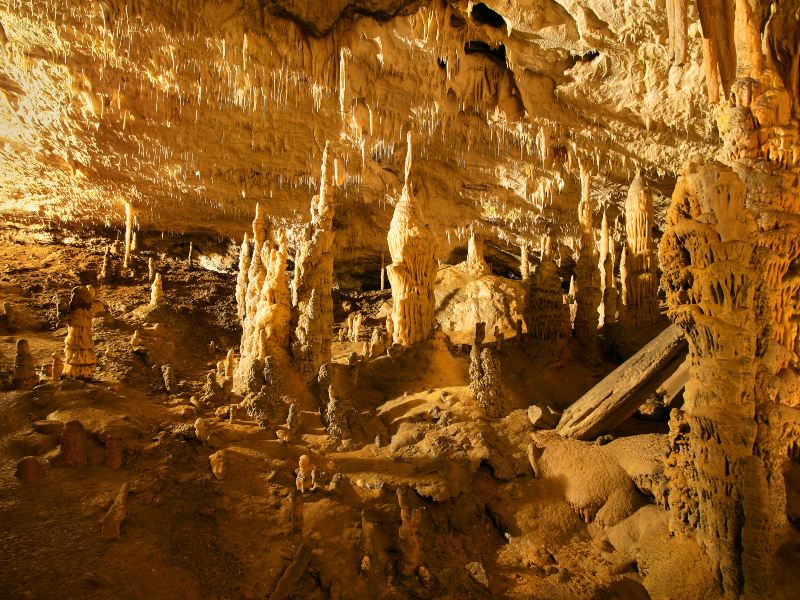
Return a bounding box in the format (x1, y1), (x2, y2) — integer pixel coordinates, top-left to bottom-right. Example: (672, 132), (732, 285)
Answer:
(574, 163), (603, 360)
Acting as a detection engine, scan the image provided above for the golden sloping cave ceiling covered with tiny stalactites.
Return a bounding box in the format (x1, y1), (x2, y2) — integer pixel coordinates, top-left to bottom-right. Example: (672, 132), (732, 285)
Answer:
(0, 0), (719, 255)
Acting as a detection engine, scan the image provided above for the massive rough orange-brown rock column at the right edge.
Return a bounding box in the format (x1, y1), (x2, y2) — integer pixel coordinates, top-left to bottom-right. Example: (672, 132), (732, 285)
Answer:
(660, 7), (800, 597)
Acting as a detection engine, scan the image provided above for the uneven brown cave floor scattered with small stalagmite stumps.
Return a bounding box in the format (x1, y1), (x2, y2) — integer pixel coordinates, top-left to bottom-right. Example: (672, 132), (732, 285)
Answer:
(0, 234), (792, 599)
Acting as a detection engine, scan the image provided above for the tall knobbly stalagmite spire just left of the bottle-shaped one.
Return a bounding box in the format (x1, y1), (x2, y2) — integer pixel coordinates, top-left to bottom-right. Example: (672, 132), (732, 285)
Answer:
(292, 144), (334, 382)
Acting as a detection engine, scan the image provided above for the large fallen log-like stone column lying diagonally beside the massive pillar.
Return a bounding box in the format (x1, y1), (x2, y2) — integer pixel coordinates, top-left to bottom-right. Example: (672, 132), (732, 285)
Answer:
(556, 325), (686, 439)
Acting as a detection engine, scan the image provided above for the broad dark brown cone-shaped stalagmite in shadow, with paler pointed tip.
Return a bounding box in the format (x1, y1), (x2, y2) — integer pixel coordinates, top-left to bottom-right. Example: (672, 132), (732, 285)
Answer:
(525, 236), (571, 340)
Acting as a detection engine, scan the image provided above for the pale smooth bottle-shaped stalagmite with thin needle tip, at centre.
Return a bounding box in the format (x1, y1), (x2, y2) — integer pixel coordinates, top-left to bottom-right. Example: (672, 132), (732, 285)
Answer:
(387, 132), (436, 346)
